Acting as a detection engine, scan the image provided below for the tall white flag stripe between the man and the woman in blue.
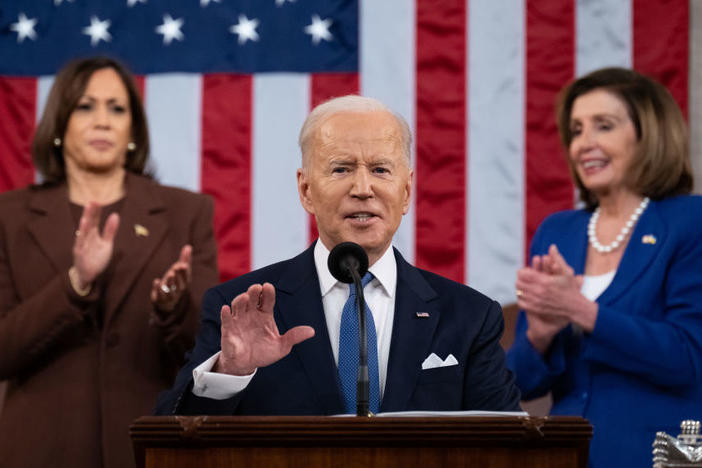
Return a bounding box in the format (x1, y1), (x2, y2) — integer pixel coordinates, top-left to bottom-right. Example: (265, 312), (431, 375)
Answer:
(466, 0), (525, 304)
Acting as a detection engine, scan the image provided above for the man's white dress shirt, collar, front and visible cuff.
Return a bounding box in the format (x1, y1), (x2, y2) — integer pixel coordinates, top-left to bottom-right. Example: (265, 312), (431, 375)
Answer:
(193, 241), (397, 400)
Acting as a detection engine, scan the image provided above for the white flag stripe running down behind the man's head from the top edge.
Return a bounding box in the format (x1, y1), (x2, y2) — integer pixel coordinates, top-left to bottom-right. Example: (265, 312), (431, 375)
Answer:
(359, 0), (415, 263)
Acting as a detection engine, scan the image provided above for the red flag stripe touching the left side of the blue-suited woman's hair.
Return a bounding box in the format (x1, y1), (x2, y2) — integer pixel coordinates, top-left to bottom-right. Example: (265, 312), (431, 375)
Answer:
(525, 0), (575, 255)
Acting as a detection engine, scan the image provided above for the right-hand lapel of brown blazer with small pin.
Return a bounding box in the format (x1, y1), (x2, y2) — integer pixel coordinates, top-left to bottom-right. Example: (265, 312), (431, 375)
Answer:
(105, 174), (168, 324)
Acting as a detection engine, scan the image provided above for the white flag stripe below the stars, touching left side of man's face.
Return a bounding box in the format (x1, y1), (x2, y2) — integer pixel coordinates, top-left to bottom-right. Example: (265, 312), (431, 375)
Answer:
(252, 73), (310, 269)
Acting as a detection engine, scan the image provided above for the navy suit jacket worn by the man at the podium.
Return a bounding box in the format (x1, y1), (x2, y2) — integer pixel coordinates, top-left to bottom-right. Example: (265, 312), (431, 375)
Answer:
(156, 243), (520, 415)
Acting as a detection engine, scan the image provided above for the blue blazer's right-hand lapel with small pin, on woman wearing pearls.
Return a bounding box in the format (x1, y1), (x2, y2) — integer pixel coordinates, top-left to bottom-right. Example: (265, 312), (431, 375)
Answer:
(597, 202), (667, 304)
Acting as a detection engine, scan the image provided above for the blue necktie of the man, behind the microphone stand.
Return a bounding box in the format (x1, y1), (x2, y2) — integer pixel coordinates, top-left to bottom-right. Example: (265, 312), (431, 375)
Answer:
(339, 272), (380, 414)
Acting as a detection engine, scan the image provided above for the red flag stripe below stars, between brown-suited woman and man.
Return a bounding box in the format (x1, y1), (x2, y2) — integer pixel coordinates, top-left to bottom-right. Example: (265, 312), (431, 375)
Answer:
(201, 74), (253, 280)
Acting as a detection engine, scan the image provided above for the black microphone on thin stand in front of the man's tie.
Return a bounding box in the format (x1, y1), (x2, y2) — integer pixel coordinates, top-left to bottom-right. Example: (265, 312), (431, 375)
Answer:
(327, 242), (370, 417)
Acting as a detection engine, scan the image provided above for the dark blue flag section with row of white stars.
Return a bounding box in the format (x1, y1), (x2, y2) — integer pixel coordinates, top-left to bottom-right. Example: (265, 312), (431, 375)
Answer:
(0, 0), (358, 76)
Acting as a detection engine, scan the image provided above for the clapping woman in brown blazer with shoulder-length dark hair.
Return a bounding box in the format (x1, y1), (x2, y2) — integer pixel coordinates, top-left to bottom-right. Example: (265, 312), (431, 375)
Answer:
(0, 58), (218, 468)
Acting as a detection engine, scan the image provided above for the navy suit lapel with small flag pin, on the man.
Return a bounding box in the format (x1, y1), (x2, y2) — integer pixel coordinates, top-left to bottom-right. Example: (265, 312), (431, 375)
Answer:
(380, 250), (440, 412)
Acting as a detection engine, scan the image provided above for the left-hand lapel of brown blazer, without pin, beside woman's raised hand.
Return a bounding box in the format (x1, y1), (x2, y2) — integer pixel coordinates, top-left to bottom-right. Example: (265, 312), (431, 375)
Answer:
(28, 184), (75, 271)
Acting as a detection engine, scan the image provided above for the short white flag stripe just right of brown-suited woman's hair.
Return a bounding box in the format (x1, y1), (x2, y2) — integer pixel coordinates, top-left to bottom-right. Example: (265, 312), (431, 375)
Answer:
(144, 73), (202, 191)
